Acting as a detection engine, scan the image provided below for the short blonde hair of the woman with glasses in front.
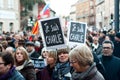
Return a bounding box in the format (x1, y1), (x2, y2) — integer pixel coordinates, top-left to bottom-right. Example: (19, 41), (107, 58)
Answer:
(69, 44), (93, 66)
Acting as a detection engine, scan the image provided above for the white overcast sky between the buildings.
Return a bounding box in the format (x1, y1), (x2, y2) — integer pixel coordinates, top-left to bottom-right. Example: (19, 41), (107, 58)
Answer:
(50, 0), (77, 15)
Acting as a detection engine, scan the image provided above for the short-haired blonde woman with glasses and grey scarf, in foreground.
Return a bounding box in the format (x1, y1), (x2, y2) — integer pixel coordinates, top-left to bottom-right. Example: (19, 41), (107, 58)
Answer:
(69, 44), (105, 80)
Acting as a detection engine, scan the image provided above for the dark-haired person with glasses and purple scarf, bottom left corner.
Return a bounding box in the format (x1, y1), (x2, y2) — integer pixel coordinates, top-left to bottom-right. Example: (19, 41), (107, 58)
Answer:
(0, 52), (25, 80)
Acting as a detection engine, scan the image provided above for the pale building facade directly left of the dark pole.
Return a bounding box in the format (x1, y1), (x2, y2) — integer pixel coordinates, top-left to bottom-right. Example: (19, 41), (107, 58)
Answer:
(96, 0), (115, 30)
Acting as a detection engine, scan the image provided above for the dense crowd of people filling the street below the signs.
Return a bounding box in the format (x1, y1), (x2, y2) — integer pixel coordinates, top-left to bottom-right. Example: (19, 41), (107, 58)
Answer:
(0, 31), (120, 80)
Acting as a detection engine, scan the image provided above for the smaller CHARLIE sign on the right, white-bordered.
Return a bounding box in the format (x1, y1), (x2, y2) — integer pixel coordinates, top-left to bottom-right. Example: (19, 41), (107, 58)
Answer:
(68, 22), (87, 44)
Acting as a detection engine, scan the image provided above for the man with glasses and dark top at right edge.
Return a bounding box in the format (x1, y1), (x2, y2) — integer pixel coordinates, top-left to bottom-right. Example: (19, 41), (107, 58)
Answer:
(100, 40), (120, 80)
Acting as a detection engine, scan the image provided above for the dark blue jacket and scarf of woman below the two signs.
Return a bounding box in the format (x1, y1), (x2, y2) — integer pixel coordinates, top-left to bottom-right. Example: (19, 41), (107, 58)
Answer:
(53, 62), (72, 80)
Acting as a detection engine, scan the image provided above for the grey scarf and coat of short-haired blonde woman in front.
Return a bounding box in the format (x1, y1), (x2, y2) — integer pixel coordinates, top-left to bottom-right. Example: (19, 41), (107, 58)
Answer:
(72, 63), (105, 80)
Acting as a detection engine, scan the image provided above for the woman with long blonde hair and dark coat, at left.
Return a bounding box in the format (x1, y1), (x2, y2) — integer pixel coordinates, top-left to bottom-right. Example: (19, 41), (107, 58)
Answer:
(14, 47), (36, 80)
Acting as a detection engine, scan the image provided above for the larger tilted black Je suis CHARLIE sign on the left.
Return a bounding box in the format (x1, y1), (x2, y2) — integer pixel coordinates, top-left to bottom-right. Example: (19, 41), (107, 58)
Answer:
(40, 18), (65, 48)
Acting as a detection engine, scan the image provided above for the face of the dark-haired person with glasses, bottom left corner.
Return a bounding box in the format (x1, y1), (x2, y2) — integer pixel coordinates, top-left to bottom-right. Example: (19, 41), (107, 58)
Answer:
(0, 57), (10, 76)
